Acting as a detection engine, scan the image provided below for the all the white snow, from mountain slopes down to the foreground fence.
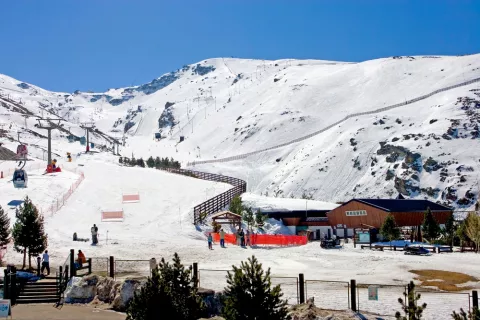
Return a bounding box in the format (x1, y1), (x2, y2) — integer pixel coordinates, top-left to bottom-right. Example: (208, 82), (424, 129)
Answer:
(0, 54), (480, 319)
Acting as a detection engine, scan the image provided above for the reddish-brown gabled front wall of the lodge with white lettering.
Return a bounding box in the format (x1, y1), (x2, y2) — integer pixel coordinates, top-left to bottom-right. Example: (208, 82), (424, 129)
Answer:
(327, 201), (387, 228)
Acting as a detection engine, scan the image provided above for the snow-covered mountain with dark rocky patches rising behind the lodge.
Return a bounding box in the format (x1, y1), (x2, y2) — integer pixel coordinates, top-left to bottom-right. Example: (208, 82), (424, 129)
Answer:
(0, 54), (480, 210)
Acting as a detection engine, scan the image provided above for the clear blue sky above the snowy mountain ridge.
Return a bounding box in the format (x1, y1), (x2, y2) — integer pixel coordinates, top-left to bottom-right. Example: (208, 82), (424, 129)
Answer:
(0, 0), (480, 92)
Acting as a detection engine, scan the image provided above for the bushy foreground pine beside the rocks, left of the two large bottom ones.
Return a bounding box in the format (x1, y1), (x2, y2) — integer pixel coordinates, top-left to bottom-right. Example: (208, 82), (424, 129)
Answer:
(127, 253), (206, 320)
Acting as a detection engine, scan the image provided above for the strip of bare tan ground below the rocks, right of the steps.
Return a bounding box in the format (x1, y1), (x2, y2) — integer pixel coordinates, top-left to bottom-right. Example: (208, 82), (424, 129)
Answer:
(12, 304), (126, 320)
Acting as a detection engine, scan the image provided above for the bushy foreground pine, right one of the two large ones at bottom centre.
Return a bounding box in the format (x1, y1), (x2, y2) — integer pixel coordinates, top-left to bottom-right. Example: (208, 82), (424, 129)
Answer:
(223, 256), (290, 320)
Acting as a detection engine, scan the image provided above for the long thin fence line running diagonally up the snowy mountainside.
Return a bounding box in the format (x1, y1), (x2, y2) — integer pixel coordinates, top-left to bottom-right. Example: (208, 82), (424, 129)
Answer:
(187, 78), (480, 166)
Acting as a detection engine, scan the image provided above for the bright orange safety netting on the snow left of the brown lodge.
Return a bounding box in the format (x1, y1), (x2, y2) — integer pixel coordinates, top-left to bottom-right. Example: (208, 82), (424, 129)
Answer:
(212, 232), (308, 247)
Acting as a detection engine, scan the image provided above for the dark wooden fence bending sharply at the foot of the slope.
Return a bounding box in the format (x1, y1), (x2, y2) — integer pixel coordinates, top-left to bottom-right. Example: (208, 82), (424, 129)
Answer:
(161, 168), (247, 224)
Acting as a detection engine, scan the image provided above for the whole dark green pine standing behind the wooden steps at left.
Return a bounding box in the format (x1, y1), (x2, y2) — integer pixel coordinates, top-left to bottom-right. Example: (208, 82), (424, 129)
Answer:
(12, 196), (47, 268)
